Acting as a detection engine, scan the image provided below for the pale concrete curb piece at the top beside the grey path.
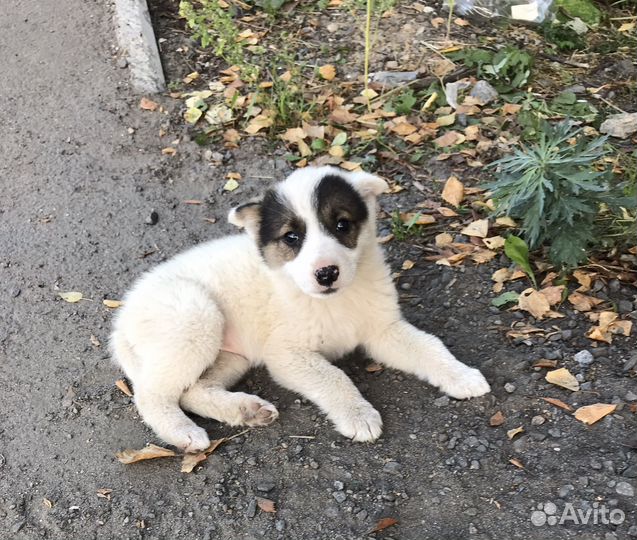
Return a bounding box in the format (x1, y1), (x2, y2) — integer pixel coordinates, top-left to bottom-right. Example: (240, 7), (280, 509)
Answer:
(115, 0), (166, 93)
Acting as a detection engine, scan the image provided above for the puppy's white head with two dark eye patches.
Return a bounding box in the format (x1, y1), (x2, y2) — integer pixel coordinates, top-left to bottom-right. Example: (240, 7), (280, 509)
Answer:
(228, 167), (387, 297)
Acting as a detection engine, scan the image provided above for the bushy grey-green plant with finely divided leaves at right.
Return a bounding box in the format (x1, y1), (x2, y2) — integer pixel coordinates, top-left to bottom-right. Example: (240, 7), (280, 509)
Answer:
(486, 122), (635, 268)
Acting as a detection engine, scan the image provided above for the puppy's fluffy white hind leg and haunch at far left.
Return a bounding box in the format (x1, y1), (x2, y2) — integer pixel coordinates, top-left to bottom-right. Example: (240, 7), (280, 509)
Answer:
(116, 278), (224, 452)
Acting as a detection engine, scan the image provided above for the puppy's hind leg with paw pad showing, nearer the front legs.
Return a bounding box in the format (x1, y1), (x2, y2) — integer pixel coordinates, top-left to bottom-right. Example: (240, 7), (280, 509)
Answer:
(180, 351), (279, 426)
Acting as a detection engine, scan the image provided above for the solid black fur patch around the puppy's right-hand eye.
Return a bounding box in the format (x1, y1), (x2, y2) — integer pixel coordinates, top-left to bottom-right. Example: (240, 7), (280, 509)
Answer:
(314, 174), (368, 249)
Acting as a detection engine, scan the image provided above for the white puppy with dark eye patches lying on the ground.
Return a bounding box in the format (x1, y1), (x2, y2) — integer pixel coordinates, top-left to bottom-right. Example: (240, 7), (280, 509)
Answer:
(111, 167), (490, 452)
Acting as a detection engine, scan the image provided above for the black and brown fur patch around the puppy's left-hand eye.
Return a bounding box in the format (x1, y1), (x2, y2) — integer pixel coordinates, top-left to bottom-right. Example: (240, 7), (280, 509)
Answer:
(259, 190), (305, 267)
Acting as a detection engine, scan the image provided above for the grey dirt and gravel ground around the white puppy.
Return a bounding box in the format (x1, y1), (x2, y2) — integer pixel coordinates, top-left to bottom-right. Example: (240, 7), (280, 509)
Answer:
(0, 0), (637, 540)
